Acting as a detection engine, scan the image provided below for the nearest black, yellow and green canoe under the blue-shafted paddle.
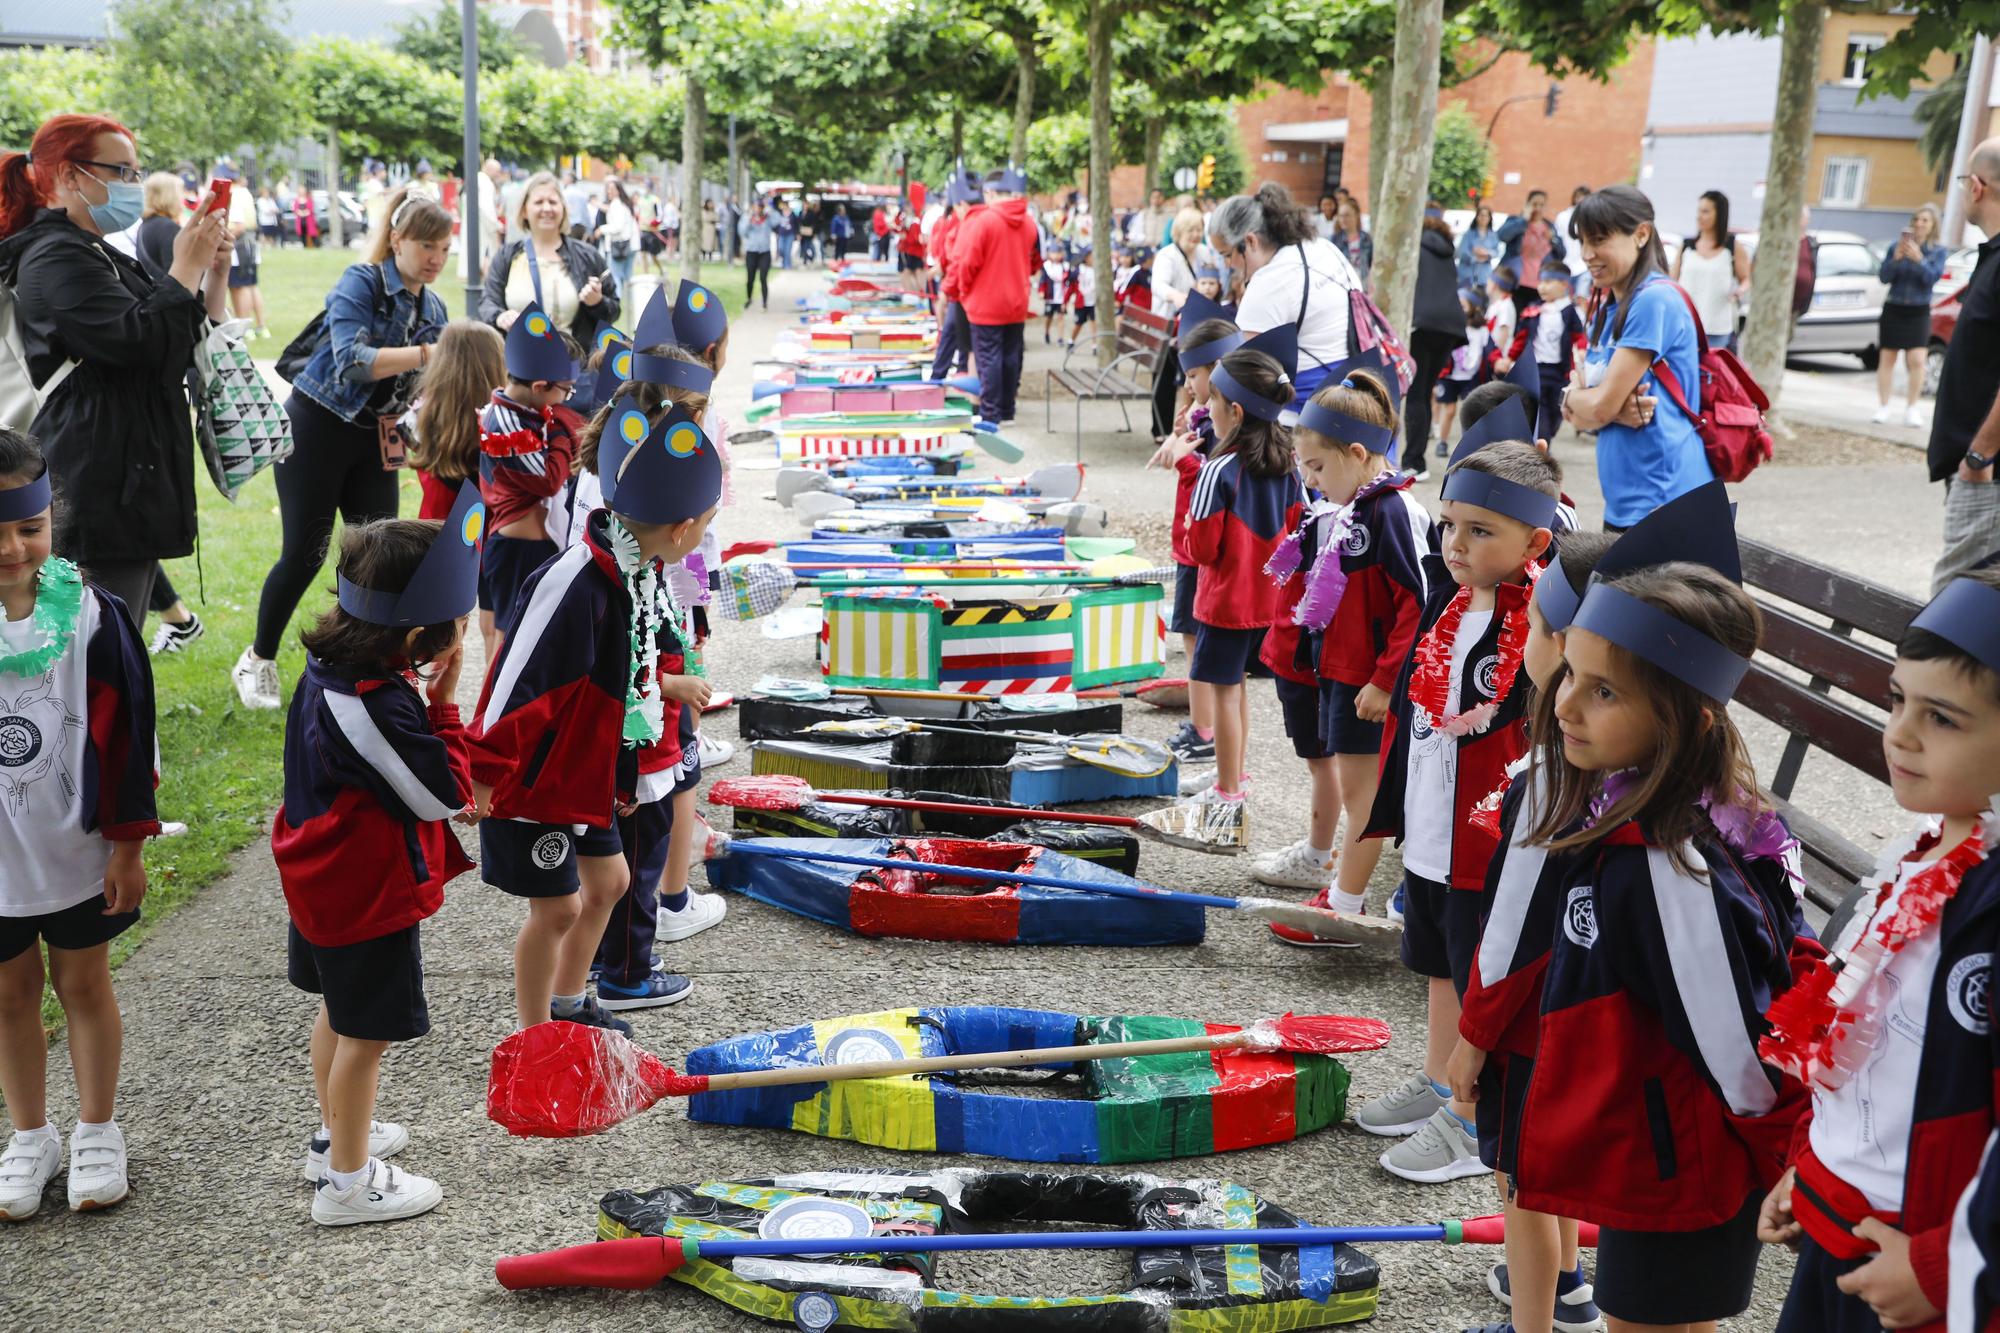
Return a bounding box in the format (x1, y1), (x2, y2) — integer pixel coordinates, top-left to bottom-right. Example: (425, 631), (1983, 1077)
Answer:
(598, 1169), (1382, 1333)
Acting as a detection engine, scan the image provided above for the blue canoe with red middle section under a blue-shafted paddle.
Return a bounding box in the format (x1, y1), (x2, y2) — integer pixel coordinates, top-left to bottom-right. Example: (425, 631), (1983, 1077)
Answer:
(702, 837), (1208, 949)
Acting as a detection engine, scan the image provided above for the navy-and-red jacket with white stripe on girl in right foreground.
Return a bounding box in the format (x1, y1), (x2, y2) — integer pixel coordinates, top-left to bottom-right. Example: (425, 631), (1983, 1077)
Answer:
(1512, 823), (1814, 1231)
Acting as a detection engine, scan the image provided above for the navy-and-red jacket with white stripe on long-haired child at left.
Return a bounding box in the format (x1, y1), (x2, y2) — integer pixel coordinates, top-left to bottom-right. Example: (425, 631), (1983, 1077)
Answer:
(270, 656), (472, 949)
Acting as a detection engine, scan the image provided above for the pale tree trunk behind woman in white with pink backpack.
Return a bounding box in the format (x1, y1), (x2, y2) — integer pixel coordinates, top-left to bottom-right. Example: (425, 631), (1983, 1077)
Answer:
(1372, 0), (1448, 336)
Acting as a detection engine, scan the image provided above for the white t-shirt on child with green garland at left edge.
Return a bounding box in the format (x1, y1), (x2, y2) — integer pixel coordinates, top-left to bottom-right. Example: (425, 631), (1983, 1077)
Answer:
(0, 590), (112, 917)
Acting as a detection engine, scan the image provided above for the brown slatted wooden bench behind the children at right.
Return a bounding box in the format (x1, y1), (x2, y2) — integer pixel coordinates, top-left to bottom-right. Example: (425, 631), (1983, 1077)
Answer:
(1736, 536), (1924, 929)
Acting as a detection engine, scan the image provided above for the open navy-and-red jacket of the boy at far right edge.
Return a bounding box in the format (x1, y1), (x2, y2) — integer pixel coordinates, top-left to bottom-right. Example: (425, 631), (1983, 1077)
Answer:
(1780, 844), (2000, 1333)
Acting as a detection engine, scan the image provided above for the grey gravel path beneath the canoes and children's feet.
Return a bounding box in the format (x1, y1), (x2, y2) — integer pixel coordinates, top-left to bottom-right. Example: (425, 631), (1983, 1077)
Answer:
(11, 272), (1938, 1333)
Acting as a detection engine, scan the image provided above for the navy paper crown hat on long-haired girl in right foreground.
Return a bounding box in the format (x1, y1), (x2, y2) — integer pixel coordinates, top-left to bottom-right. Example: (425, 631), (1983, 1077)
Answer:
(1570, 482), (1750, 703)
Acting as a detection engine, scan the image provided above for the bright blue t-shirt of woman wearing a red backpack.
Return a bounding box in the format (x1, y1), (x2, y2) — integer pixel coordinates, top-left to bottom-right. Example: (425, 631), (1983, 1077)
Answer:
(1584, 276), (1716, 528)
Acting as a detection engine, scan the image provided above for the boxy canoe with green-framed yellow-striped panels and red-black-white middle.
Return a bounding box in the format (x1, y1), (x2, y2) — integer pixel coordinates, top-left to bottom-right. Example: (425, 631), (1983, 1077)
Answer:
(818, 584), (1166, 695)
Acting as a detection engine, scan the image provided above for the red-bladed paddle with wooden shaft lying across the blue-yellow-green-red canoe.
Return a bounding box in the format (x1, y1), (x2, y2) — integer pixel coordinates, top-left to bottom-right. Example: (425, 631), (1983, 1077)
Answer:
(486, 1013), (1390, 1139)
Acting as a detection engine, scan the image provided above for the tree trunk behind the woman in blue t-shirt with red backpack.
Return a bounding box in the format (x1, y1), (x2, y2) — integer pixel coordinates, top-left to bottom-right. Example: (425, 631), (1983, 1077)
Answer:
(1744, 4), (1826, 410)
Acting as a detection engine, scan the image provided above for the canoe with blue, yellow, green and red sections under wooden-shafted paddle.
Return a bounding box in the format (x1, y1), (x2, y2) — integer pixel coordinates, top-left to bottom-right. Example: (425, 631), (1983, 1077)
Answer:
(688, 1005), (1348, 1165)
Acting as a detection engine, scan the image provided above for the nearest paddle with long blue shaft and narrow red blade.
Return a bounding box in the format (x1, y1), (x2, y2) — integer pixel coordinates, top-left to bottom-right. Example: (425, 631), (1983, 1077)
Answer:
(494, 1213), (1598, 1291)
